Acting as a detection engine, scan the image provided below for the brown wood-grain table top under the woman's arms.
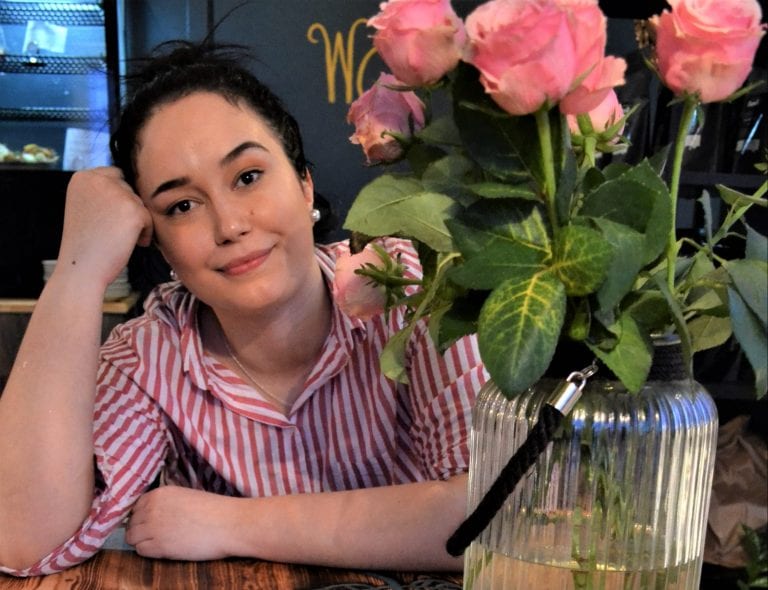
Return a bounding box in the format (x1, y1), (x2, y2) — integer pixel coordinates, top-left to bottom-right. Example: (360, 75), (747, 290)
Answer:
(0, 549), (461, 590)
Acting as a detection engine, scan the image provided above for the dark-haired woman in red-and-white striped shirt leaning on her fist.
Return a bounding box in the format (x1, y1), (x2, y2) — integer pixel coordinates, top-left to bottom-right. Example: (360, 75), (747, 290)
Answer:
(0, 44), (486, 575)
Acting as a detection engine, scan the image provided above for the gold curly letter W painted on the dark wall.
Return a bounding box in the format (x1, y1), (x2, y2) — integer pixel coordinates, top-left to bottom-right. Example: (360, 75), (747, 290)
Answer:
(307, 18), (376, 104)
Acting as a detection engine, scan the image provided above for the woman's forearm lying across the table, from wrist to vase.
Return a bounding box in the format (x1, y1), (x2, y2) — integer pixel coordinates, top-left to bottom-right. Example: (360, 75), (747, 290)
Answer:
(232, 476), (467, 571)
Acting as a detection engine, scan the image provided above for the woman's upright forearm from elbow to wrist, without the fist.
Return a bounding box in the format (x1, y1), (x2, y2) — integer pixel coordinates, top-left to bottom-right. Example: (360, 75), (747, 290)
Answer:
(0, 272), (103, 567)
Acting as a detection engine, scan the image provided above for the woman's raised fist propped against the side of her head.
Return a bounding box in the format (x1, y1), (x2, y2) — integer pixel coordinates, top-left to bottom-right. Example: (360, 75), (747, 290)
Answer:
(56, 167), (152, 288)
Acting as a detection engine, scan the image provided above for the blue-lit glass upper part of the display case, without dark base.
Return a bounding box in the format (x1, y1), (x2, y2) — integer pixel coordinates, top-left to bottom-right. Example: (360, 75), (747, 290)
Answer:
(0, 0), (118, 170)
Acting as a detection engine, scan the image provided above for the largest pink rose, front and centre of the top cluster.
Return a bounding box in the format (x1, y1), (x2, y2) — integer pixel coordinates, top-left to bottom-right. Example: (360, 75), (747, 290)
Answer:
(464, 0), (584, 115)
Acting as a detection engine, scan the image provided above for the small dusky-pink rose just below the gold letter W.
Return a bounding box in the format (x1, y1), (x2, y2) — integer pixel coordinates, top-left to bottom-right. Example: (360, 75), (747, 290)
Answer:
(347, 73), (424, 163)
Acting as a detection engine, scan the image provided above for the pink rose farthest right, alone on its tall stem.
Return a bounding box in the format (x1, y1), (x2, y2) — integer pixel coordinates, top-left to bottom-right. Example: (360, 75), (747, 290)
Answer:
(651, 0), (765, 103)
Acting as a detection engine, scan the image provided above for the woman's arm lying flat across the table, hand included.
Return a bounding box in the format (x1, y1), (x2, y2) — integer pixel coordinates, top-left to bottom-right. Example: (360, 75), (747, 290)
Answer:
(126, 475), (467, 571)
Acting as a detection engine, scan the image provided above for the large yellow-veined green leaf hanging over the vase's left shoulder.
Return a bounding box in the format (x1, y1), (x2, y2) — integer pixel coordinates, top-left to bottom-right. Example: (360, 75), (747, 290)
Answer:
(477, 273), (565, 397)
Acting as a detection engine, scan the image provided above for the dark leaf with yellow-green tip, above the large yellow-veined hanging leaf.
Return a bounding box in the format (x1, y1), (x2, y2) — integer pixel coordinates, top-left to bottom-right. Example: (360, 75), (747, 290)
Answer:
(446, 199), (550, 258)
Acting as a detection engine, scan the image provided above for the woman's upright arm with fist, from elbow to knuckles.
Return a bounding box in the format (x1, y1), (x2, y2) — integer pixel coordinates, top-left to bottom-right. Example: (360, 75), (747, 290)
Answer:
(0, 168), (151, 569)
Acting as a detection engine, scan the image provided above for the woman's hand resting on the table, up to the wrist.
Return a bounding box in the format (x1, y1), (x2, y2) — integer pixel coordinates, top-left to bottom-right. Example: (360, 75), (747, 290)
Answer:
(125, 485), (236, 560)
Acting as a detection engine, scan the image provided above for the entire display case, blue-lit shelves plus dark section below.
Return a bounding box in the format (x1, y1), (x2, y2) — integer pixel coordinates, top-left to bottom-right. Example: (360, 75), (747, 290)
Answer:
(0, 0), (120, 298)
